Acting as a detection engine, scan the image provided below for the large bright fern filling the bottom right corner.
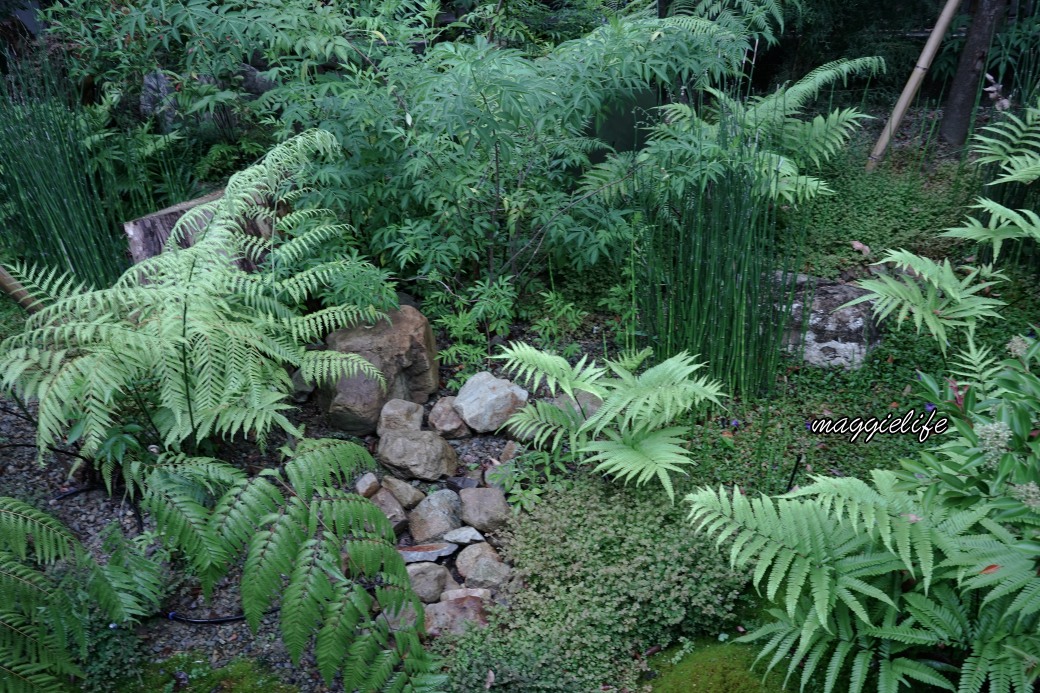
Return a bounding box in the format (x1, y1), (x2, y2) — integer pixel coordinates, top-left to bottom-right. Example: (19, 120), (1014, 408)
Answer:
(687, 470), (1040, 693)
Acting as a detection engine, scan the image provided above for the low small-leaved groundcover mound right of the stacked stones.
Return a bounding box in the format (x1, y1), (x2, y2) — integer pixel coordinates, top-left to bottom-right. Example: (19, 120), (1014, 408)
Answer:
(442, 477), (745, 693)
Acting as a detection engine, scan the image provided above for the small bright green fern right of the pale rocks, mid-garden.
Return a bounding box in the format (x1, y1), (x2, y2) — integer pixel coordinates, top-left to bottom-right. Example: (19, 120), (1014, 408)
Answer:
(498, 343), (723, 497)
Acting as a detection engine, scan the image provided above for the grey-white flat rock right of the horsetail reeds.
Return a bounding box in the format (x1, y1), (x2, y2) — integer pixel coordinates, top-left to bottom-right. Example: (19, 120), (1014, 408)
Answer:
(785, 280), (880, 368)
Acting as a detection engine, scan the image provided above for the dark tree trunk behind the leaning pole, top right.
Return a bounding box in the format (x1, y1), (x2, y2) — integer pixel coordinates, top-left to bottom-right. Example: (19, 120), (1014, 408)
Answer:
(939, 0), (1008, 146)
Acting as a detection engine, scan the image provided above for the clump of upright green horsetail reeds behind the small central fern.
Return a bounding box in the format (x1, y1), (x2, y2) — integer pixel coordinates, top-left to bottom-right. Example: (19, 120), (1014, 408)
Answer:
(635, 142), (803, 397)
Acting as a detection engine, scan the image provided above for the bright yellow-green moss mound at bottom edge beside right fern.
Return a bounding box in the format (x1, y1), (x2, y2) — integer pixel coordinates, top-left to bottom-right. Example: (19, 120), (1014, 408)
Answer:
(650, 639), (797, 693)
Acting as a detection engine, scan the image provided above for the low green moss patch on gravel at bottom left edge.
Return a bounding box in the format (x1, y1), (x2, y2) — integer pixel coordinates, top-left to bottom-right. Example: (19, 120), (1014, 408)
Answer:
(116, 652), (300, 693)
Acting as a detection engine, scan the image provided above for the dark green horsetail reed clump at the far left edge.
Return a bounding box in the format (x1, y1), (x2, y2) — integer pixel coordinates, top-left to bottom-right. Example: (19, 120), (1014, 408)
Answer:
(0, 55), (128, 286)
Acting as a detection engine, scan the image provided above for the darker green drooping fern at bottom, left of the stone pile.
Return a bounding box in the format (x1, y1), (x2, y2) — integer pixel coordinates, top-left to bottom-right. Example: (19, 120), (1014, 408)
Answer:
(142, 439), (440, 691)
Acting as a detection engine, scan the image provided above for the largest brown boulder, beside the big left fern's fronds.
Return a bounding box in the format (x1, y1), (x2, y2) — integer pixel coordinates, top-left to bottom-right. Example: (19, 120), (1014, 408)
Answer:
(320, 306), (439, 436)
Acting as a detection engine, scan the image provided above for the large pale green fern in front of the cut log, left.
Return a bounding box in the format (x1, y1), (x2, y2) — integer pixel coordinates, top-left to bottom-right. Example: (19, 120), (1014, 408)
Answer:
(0, 131), (381, 482)
